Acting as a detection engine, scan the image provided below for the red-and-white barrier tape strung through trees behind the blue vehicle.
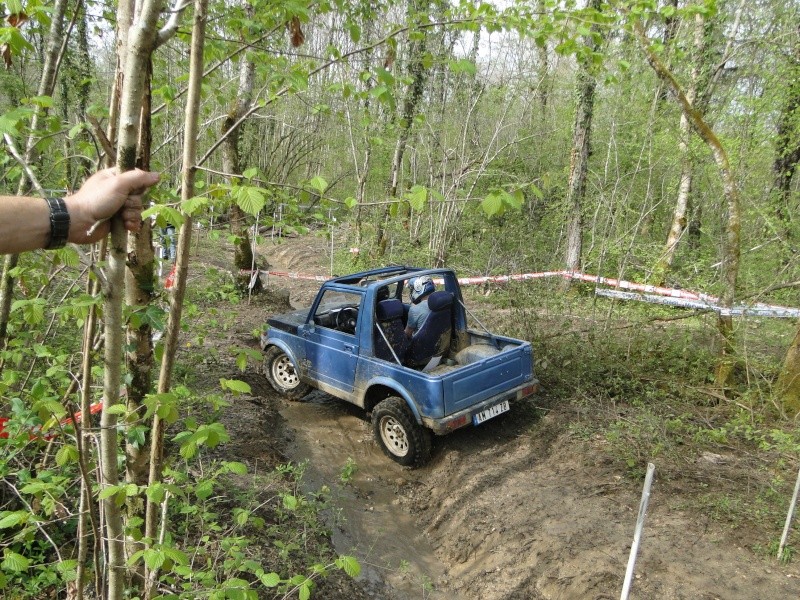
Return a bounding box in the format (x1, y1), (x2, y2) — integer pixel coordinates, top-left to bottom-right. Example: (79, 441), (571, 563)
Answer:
(240, 269), (800, 318)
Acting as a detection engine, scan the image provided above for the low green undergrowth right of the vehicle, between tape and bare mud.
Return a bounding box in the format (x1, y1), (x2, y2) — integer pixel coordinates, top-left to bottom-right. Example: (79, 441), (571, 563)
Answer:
(476, 281), (800, 561)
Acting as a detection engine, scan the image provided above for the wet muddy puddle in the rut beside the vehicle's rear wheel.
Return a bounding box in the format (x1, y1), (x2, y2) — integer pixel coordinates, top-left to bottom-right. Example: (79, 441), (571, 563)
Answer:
(280, 392), (443, 600)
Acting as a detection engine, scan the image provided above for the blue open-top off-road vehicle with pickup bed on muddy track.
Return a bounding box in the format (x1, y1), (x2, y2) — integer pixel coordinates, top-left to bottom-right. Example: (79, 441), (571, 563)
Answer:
(261, 267), (539, 466)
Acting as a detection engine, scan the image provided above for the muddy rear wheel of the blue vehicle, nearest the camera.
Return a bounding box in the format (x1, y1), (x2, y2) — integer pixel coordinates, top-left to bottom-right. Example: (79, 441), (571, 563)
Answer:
(372, 396), (431, 467)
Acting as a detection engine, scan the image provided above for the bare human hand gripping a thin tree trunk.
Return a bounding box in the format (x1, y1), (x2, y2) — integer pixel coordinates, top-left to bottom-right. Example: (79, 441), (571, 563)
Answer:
(64, 168), (160, 244)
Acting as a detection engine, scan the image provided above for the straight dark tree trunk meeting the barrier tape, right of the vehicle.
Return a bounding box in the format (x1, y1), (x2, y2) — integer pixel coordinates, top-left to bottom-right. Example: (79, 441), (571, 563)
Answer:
(564, 0), (601, 271)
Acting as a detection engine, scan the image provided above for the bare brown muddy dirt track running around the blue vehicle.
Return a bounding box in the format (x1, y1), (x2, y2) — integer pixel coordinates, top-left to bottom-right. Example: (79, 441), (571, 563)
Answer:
(184, 231), (800, 600)
